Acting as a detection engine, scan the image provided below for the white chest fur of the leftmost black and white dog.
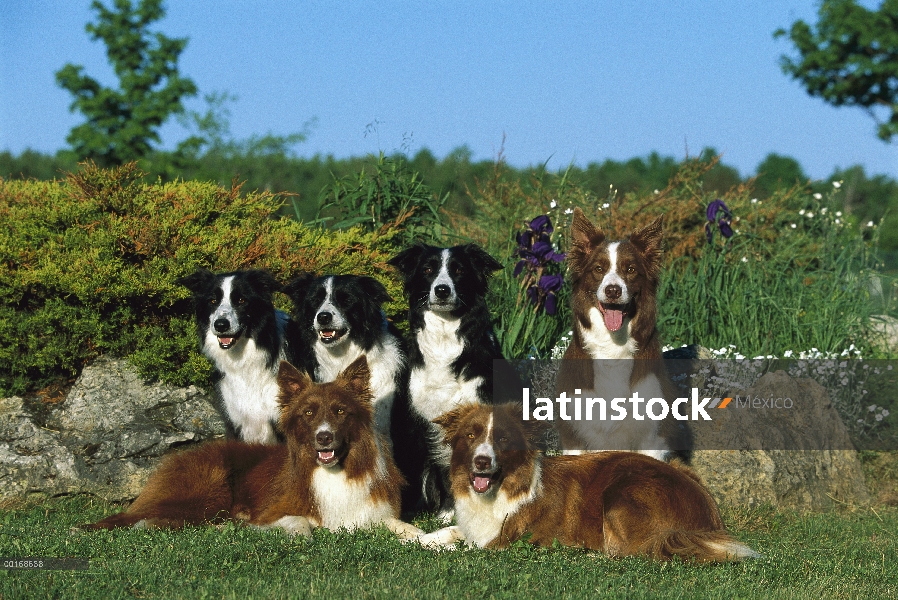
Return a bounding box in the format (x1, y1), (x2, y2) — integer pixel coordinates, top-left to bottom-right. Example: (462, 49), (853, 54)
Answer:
(203, 331), (284, 444)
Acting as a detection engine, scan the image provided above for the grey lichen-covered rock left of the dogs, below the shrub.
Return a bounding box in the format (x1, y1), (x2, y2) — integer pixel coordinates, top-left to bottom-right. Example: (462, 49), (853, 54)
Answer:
(0, 358), (224, 502)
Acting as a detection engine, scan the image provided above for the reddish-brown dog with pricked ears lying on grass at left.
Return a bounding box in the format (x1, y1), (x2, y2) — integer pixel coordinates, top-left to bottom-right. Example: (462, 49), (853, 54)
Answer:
(86, 355), (422, 539)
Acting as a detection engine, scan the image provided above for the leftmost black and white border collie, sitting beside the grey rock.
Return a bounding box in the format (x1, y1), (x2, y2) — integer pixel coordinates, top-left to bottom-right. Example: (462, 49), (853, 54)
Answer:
(176, 269), (298, 444)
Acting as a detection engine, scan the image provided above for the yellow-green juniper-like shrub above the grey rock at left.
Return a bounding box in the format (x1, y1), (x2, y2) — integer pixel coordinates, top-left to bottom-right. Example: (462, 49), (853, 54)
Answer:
(0, 165), (404, 394)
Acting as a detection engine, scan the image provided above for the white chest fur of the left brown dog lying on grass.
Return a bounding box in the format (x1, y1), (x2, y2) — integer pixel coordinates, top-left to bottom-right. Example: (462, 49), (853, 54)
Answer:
(312, 466), (390, 530)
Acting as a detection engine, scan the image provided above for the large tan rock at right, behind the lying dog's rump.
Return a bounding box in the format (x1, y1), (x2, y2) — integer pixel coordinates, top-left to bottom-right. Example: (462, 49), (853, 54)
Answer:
(692, 371), (870, 512)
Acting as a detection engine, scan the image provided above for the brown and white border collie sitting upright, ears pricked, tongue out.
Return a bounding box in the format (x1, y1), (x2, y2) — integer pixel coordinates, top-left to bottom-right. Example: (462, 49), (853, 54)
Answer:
(556, 208), (688, 460)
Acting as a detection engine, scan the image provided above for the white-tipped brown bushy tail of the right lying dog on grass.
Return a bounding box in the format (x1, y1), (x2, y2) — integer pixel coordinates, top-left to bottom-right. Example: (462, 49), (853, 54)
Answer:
(643, 530), (761, 562)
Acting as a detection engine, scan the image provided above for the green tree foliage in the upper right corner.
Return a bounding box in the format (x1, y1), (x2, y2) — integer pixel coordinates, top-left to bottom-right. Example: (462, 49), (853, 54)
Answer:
(774, 0), (898, 141)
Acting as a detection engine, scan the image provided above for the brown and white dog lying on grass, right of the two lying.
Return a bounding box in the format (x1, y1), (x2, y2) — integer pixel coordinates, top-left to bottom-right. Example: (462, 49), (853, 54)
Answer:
(418, 404), (758, 561)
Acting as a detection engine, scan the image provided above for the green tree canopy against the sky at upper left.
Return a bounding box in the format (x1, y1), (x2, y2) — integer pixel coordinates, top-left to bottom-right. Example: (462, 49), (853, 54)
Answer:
(56, 0), (197, 166)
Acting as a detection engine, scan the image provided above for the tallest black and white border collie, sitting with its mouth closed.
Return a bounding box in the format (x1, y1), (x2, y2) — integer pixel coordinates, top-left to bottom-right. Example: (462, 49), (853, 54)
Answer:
(389, 244), (502, 518)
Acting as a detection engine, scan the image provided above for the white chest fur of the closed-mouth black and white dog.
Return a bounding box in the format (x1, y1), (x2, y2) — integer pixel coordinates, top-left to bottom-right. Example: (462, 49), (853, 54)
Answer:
(409, 311), (483, 421)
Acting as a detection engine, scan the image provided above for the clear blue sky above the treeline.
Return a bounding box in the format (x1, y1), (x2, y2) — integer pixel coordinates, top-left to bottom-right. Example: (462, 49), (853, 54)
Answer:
(0, 0), (898, 178)
